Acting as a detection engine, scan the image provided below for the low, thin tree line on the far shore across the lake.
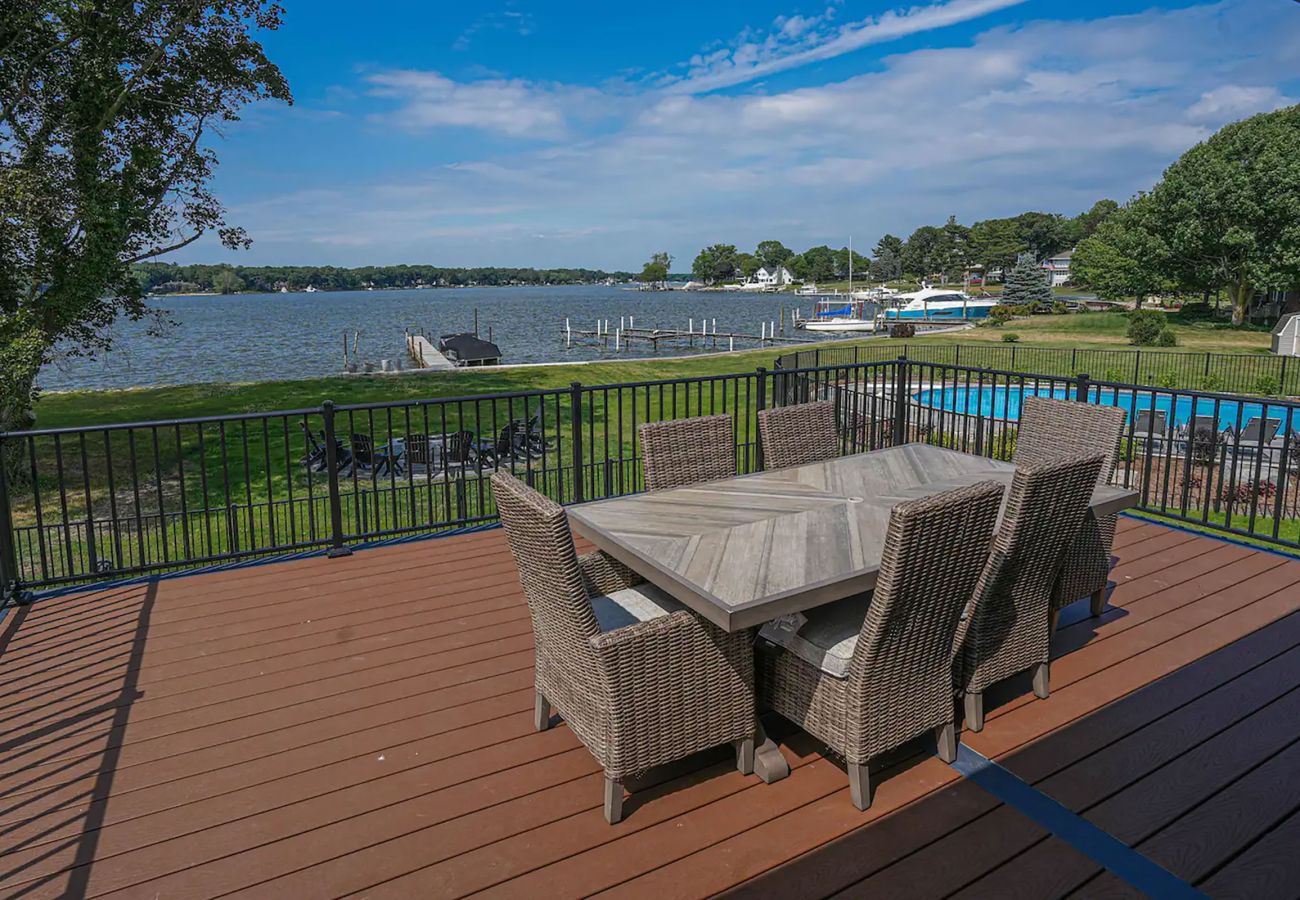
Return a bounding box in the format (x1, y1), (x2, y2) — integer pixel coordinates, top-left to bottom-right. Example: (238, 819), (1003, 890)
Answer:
(134, 263), (632, 294)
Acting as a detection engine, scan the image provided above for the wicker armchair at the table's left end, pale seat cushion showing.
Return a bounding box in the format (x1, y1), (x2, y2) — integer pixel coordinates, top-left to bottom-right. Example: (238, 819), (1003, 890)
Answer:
(491, 472), (758, 825)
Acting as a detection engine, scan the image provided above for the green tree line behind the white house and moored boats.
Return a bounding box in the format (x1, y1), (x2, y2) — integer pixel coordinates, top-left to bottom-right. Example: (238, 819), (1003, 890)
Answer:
(690, 200), (1119, 284)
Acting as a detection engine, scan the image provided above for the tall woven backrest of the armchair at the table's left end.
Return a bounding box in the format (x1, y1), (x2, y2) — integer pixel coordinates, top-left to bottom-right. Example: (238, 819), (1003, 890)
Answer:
(491, 472), (599, 660)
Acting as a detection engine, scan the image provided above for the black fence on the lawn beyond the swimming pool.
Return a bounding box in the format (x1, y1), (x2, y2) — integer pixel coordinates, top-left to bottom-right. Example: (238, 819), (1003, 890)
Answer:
(774, 343), (1300, 397)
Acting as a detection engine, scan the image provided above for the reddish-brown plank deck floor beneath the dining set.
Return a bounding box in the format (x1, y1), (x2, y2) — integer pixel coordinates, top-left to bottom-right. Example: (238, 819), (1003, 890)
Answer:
(0, 519), (1300, 900)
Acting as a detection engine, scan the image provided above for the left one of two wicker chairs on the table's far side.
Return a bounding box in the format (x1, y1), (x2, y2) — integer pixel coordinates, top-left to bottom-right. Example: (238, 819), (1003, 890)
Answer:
(640, 416), (736, 490)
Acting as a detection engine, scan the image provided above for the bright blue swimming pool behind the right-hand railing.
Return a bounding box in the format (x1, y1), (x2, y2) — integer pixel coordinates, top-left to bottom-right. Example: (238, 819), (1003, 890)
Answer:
(913, 385), (1300, 434)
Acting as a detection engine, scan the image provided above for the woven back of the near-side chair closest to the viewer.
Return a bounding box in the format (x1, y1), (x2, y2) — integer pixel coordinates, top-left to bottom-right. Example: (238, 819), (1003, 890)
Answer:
(849, 481), (1004, 758)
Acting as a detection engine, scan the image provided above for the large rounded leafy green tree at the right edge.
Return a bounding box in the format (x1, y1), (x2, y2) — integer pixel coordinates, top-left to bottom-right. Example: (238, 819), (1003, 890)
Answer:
(1149, 105), (1300, 325)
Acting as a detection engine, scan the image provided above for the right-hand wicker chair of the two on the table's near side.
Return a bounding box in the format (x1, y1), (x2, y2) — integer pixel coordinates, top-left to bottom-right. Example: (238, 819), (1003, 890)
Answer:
(953, 453), (1105, 731)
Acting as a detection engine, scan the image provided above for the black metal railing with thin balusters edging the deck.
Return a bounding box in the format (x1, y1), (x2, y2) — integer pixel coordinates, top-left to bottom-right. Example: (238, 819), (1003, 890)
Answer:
(0, 356), (1300, 593)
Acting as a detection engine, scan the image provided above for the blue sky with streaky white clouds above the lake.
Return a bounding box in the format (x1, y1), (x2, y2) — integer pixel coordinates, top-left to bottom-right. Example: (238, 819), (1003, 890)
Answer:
(172, 0), (1300, 271)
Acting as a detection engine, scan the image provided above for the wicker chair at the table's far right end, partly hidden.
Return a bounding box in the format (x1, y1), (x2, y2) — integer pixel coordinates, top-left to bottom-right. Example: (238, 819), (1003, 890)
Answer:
(1011, 397), (1127, 621)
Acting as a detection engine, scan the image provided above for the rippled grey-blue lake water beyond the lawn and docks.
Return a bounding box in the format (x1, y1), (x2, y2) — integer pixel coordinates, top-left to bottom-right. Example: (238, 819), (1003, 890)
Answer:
(40, 285), (873, 390)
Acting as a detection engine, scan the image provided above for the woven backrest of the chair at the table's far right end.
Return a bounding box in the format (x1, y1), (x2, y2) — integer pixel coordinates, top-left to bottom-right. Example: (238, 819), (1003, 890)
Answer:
(1011, 397), (1127, 484)
